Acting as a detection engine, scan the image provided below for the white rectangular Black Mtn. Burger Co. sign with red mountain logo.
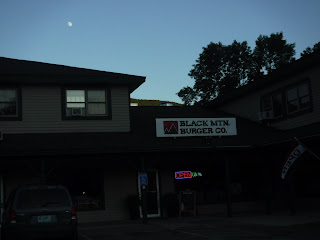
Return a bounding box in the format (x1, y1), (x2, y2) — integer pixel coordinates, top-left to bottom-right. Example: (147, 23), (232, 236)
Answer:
(156, 118), (237, 137)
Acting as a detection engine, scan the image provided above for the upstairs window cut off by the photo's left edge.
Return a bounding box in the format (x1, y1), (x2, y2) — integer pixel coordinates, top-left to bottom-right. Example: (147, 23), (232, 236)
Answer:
(0, 88), (21, 120)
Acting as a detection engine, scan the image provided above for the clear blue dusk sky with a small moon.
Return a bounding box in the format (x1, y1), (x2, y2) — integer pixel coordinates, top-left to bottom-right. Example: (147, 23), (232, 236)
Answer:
(0, 0), (320, 102)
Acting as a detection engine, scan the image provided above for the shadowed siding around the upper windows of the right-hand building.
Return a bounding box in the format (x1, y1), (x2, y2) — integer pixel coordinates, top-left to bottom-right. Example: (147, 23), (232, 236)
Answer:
(219, 68), (320, 130)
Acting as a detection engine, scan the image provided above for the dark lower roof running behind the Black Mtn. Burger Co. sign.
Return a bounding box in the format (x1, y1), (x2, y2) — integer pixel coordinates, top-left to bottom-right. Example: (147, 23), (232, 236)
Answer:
(0, 107), (281, 156)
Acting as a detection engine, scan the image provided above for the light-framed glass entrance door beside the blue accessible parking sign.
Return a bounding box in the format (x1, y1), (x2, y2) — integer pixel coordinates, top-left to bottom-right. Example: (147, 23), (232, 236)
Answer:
(138, 171), (160, 218)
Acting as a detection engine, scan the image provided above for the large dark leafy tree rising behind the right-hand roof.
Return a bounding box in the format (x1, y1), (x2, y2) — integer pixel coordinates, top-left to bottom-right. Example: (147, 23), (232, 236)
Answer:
(177, 32), (295, 105)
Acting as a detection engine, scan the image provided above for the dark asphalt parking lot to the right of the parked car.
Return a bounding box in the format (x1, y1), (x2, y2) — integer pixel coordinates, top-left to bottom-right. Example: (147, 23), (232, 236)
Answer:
(79, 212), (320, 240)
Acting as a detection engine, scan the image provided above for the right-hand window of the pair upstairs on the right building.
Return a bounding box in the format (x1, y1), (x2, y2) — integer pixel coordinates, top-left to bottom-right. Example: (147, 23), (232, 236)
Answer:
(286, 82), (311, 114)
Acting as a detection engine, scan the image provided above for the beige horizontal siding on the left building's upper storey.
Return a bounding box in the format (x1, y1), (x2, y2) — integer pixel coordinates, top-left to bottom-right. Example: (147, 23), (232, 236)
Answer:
(0, 86), (130, 134)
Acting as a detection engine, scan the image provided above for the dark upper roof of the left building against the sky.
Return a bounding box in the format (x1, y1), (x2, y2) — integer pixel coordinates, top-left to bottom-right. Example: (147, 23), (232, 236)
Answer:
(0, 57), (146, 92)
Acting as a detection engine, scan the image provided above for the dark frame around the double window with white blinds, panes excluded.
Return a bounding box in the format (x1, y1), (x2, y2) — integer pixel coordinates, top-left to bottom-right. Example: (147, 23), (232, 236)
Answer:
(61, 86), (112, 120)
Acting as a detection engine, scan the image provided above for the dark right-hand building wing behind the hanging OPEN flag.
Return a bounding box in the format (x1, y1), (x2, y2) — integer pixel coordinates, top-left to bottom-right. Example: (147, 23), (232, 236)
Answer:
(214, 54), (320, 214)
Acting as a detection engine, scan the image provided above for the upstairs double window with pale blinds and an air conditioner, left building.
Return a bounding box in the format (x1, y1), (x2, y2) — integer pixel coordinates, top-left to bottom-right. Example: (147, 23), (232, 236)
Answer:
(63, 89), (111, 119)
